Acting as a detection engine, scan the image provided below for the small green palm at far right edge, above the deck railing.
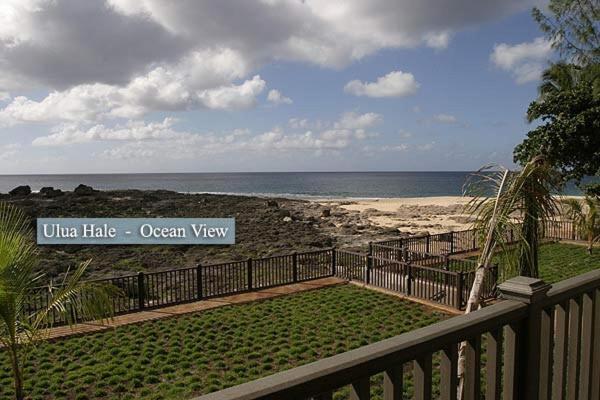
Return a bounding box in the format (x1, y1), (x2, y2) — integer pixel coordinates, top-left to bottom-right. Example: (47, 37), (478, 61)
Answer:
(563, 196), (600, 254)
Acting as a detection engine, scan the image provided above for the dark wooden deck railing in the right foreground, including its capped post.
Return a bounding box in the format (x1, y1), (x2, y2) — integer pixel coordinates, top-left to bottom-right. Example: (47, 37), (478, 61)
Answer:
(192, 270), (600, 400)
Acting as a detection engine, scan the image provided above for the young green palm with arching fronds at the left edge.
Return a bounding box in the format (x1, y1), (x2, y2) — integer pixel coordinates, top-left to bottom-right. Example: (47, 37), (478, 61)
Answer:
(0, 203), (117, 400)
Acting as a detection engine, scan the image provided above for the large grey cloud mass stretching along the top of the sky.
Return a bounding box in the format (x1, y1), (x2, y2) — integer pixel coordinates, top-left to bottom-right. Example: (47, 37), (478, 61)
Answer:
(0, 0), (533, 90)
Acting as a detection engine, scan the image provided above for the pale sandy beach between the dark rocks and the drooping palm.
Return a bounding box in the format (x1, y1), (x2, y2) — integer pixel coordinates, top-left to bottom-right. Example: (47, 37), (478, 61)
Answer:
(319, 196), (472, 234)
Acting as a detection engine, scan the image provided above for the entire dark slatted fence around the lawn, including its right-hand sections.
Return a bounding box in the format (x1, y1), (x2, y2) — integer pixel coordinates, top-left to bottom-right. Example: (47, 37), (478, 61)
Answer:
(26, 221), (581, 324)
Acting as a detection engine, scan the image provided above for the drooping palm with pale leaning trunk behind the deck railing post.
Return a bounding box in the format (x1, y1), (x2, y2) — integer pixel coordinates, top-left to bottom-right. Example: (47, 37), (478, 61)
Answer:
(458, 157), (559, 397)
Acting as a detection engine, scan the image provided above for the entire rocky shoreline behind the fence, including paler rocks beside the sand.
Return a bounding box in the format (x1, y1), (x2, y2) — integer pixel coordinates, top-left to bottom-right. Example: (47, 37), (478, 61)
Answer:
(0, 185), (399, 278)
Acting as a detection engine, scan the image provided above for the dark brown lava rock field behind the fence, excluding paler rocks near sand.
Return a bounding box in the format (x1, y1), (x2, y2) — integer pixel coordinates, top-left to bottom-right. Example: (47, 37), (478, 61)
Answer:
(5, 190), (334, 279)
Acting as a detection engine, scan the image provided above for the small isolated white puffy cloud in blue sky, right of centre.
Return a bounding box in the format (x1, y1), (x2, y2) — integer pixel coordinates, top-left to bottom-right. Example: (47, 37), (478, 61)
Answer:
(344, 71), (419, 97)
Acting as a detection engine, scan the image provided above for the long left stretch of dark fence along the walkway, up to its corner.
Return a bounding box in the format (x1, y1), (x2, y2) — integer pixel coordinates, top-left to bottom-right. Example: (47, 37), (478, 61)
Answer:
(26, 248), (335, 325)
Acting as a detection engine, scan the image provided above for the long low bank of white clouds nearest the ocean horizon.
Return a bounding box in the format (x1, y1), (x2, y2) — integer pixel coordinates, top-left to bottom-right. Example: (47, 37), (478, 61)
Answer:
(32, 113), (382, 159)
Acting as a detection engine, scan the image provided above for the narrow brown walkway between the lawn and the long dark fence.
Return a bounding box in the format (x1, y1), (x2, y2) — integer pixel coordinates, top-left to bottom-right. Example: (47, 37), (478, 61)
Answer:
(45, 277), (347, 340)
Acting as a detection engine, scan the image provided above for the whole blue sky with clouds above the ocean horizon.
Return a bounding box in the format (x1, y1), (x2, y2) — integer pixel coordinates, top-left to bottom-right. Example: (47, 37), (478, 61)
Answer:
(0, 0), (555, 174)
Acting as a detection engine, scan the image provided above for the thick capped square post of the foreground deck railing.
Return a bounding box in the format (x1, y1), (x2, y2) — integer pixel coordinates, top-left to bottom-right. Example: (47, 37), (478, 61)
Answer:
(498, 276), (552, 400)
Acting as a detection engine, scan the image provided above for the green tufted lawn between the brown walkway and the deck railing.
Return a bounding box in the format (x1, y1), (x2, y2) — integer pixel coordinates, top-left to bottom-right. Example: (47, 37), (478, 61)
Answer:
(0, 285), (445, 400)
